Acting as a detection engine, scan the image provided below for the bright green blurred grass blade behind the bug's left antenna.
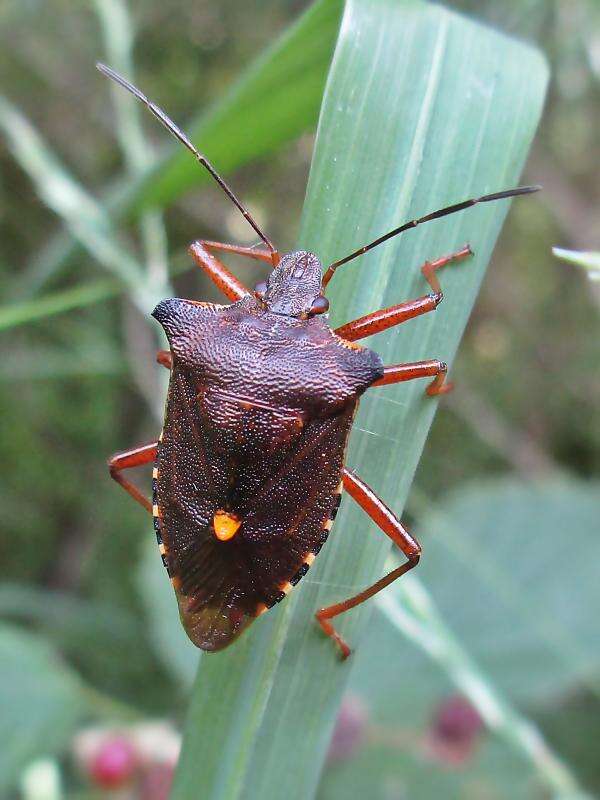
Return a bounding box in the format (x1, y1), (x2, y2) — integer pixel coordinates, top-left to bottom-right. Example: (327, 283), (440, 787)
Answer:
(19, 0), (342, 294)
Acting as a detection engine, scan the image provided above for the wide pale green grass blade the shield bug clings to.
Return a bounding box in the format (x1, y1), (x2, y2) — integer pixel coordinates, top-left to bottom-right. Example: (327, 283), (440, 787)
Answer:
(172, 0), (547, 800)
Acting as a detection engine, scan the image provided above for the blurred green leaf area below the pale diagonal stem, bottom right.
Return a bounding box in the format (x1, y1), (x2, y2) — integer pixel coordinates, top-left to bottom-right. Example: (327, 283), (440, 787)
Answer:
(317, 608), (564, 800)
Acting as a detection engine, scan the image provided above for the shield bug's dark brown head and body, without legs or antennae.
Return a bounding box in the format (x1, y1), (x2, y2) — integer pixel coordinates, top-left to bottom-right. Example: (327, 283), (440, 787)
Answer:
(154, 252), (383, 650)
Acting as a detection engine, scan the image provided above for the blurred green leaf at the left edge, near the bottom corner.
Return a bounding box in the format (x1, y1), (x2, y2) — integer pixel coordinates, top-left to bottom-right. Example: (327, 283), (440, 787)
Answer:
(0, 624), (88, 792)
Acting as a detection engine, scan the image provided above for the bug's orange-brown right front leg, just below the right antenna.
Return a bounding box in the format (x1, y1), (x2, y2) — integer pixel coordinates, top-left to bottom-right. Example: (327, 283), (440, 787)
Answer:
(335, 244), (473, 342)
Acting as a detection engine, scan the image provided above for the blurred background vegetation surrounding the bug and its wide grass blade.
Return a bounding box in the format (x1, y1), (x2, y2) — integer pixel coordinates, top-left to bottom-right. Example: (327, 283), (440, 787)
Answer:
(0, 0), (600, 798)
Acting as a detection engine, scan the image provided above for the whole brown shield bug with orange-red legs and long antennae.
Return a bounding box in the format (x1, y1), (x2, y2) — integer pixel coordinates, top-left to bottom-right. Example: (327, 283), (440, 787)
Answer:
(98, 65), (539, 657)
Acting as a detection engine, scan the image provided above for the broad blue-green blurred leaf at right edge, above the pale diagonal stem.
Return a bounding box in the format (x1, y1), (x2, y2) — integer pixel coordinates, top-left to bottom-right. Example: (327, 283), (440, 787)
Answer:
(410, 478), (600, 703)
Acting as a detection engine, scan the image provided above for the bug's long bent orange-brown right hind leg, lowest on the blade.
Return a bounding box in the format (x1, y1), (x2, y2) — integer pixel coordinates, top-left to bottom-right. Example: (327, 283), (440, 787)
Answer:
(315, 468), (421, 658)
